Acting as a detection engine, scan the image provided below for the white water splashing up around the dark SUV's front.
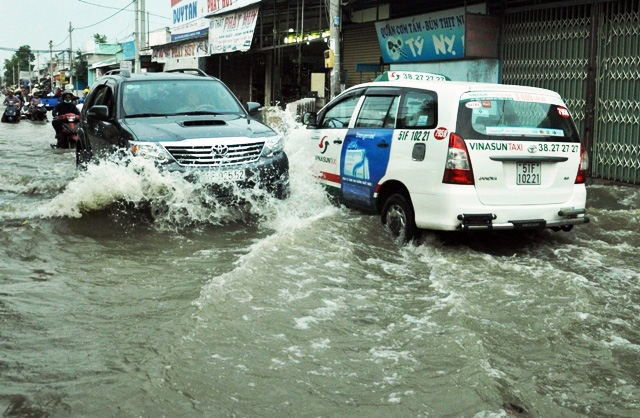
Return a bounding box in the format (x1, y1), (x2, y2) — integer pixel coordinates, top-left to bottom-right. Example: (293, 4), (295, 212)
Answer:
(23, 107), (329, 230)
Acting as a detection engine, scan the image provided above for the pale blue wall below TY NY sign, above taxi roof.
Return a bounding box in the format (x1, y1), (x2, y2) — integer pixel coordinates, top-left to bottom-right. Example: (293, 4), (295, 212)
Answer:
(390, 59), (500, 83)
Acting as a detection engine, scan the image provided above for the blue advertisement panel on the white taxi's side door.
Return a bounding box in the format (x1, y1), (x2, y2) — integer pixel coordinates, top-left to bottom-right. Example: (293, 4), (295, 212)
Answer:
(340, 128), (393, 208)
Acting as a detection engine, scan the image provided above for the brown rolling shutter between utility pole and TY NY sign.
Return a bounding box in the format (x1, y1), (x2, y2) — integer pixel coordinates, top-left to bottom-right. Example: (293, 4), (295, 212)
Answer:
(342, 22), (381, 88)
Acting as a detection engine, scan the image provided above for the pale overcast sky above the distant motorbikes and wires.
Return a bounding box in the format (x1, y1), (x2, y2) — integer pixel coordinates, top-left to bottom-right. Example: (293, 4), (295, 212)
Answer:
(0, 0), (171, 74)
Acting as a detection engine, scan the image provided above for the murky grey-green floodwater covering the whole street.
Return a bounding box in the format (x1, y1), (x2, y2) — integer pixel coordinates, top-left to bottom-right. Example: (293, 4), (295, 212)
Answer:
(0, 114), (640, 417)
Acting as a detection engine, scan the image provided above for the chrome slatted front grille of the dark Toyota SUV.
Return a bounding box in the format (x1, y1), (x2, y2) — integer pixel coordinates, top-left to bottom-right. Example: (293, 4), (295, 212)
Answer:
(163, 142), (264, 166)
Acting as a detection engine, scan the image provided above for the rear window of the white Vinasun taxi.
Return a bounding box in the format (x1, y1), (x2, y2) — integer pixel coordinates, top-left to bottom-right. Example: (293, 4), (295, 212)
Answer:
(456, 92), (580, 142)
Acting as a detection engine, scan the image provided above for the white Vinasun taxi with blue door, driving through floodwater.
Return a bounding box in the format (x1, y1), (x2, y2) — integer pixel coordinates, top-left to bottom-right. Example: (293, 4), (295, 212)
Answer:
(304, 72), (589, 240)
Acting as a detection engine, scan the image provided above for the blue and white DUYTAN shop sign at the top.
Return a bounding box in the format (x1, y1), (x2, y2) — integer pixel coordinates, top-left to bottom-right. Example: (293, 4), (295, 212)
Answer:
(170, 0), (209, 42)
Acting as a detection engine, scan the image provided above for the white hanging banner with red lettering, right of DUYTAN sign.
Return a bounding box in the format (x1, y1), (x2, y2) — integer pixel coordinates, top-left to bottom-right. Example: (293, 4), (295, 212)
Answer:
(209, 7), (259, 55)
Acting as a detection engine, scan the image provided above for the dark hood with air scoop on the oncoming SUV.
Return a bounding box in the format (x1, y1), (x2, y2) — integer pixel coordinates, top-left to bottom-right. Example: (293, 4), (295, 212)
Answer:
(123, 116), (276, 142)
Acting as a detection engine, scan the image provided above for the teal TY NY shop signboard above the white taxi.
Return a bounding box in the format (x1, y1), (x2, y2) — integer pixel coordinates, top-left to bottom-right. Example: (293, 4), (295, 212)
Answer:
(376, 4), (486, 63)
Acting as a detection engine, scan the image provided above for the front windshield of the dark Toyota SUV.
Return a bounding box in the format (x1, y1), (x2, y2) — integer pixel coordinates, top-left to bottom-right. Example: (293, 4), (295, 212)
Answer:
(122, 79), (245, 117)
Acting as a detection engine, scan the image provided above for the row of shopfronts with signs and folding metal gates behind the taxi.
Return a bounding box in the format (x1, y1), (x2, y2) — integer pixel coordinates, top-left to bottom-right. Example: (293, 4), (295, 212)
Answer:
(146, 0), (640, 184)
